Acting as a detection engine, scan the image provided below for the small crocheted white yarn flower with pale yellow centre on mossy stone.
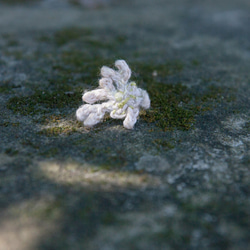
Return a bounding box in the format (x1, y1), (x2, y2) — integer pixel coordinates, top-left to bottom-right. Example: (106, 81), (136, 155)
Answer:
(76, 60), (150, 129)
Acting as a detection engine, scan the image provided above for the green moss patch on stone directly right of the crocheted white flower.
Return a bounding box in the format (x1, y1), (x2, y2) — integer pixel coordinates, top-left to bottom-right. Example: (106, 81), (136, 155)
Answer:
(135, 61), (234, 131)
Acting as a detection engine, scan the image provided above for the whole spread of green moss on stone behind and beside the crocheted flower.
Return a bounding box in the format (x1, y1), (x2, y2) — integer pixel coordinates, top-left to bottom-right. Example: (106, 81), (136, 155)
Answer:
(7, 27), (234, 135)
